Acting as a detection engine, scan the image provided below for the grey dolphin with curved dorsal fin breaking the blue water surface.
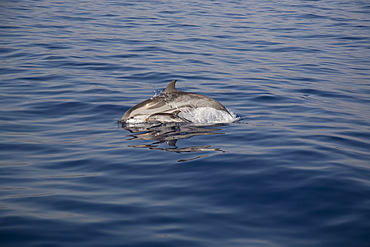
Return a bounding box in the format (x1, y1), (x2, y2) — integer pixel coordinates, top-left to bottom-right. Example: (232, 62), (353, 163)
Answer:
(120, 80), (231, 123)
